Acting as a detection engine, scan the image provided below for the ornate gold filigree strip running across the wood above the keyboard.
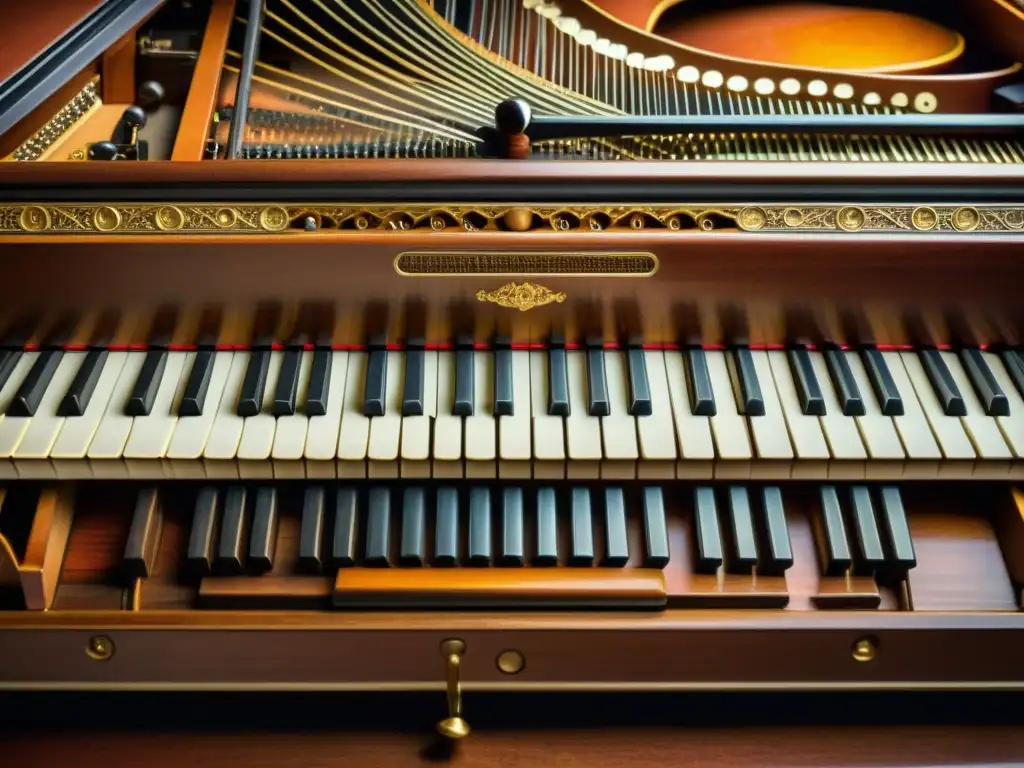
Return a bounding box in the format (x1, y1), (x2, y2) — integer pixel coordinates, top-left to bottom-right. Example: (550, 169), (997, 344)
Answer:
(0, 203), (1024, 236)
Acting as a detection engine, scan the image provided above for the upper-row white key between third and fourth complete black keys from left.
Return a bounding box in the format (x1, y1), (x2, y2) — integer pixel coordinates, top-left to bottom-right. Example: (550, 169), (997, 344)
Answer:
(124, 352), (196, 479)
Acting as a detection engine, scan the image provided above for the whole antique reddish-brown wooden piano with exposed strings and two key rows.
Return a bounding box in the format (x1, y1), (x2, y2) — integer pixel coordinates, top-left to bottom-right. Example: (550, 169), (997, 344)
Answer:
(0, 0), (1024, 737)
